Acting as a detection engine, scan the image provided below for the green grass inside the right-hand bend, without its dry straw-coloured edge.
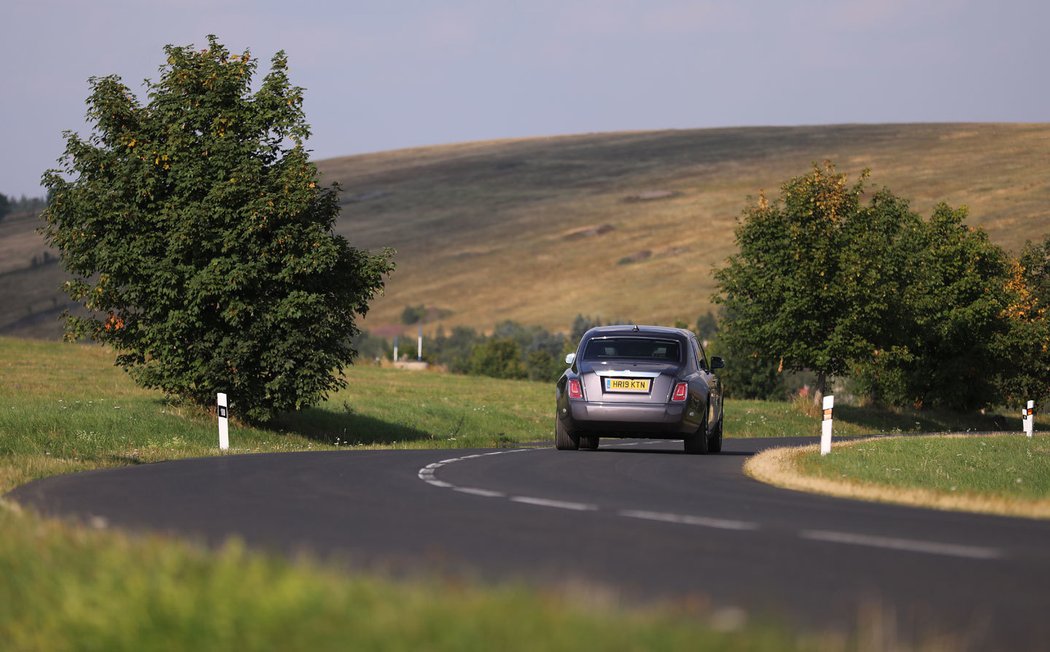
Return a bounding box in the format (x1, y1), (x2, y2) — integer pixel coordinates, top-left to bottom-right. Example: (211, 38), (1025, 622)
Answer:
(799, 434), (1050, 500)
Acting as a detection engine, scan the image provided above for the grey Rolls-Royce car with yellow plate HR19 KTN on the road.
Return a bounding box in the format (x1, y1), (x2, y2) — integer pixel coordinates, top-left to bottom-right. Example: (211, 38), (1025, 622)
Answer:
(554, 325), (726, 454)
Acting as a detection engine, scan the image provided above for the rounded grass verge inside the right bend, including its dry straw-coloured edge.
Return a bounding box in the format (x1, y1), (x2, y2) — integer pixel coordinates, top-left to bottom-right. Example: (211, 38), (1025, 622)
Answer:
(744, 435), (1050, 519)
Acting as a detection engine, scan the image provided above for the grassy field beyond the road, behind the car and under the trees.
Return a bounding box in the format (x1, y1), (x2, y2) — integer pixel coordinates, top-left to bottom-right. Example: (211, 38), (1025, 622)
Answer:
(0, 338), (1006, 491)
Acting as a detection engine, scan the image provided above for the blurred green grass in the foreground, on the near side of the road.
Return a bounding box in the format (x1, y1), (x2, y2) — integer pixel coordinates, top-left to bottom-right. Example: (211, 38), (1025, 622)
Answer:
(0, 510), (802, 651)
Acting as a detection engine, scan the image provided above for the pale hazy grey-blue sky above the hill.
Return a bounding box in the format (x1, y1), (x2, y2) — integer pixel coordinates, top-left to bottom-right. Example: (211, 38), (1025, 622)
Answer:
(0, 0), (1050, 196)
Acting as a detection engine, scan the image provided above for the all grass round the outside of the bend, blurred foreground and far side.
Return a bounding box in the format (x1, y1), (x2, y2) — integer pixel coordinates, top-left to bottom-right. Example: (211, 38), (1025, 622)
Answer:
(0, 338), (1033, 650)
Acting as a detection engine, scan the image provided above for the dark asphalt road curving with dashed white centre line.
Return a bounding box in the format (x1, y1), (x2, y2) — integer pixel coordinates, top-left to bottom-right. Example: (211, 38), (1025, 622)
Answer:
(9, 439), (1050, 650)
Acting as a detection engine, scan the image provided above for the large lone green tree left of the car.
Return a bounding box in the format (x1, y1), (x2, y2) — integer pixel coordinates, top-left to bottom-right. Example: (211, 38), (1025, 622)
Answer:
(43, 37), (393, 420)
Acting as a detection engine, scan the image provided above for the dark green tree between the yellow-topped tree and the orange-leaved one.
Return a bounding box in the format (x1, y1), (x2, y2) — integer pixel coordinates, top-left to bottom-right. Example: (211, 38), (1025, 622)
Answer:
(852, 204), (1012, 409)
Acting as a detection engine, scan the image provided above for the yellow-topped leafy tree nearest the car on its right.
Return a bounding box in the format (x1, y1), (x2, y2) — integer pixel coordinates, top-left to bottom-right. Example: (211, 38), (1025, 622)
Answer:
(715, 163), (920, 400)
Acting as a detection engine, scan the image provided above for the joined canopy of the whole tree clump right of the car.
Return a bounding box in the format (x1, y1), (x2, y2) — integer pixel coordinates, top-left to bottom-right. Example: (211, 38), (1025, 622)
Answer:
(715, 163), (1050, 409)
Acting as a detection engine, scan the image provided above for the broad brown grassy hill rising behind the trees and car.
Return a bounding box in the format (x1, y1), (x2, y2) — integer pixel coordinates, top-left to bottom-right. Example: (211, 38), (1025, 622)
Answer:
(0, 124), (1050, 335)
